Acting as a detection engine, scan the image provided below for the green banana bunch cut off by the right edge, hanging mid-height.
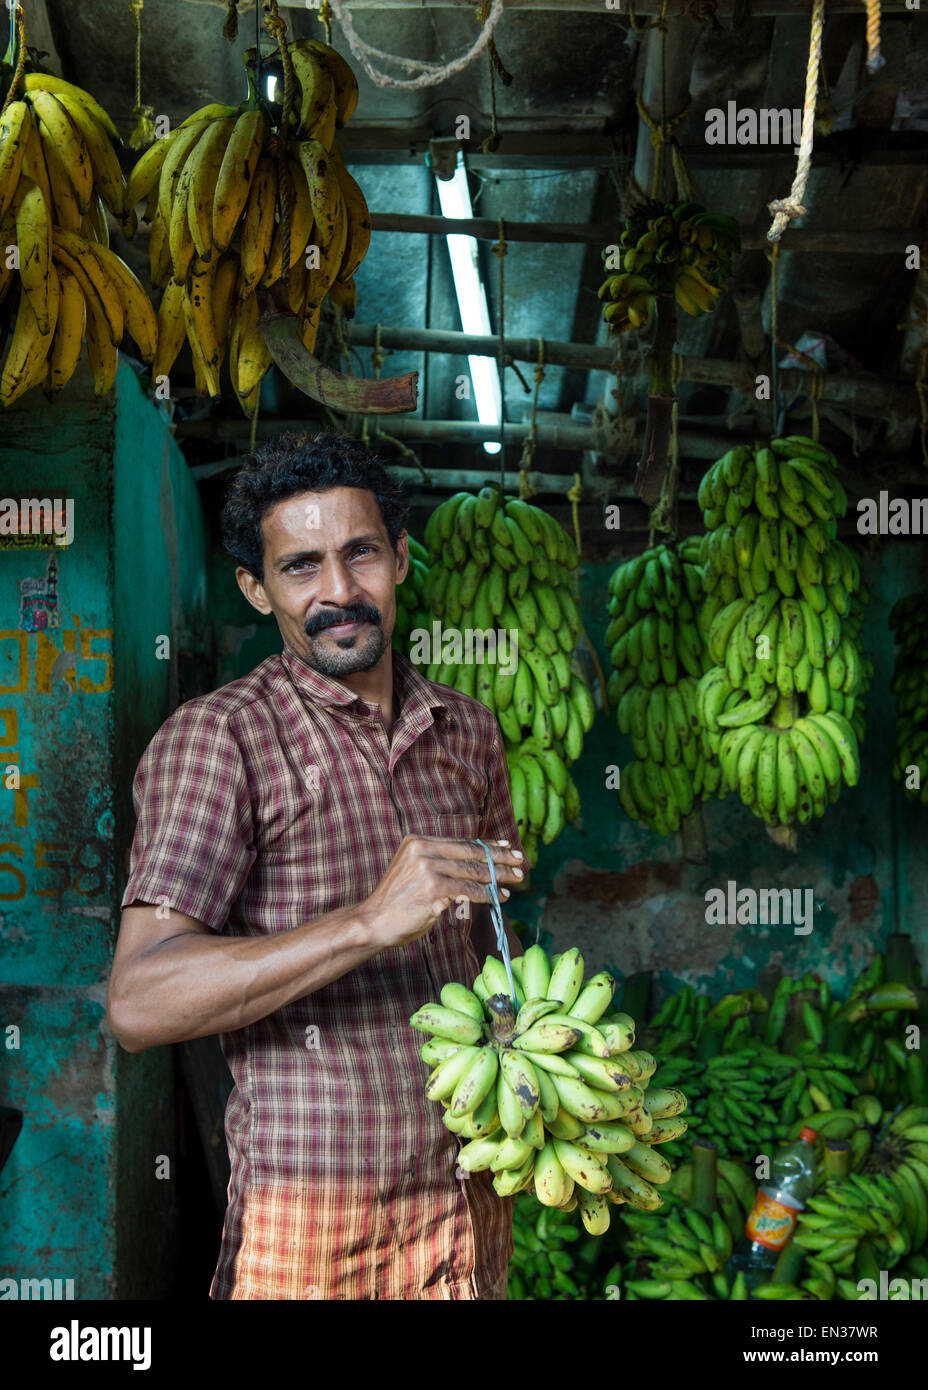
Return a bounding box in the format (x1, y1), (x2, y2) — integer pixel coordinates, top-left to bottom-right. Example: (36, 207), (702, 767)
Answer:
(889, 594), (928, 805)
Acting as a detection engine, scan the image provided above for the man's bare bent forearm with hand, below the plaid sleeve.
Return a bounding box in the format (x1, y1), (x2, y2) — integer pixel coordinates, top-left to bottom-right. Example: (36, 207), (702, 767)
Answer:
(107, 835), (522, 1052)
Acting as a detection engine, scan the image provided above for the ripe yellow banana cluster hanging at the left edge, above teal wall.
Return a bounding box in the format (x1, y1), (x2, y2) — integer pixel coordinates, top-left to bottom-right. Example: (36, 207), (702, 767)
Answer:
(0, 72), (157, 406)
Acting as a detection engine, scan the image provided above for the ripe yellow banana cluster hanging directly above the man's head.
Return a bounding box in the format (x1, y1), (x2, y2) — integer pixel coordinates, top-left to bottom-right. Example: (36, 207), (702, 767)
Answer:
(126, 39), (371, 416)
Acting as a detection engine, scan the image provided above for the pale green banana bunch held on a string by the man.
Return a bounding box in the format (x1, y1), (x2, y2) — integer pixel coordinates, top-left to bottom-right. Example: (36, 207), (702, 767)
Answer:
(410, 945), (686, 1236)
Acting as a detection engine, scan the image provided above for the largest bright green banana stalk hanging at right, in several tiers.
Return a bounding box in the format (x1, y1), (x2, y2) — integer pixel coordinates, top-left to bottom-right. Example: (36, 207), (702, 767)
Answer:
(697, 435), (872, 827)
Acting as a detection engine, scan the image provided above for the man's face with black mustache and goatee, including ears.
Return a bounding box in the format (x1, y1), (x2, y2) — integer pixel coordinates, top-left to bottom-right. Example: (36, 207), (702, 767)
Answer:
(236, 488), (408, 680)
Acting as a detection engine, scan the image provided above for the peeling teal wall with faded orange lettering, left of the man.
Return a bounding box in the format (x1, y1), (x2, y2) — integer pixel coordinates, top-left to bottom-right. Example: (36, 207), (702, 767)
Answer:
(0, 360), (210, 1300)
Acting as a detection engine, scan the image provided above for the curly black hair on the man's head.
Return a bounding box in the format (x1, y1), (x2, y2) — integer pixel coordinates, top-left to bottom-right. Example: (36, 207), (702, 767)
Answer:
(221, 431), (407, 582)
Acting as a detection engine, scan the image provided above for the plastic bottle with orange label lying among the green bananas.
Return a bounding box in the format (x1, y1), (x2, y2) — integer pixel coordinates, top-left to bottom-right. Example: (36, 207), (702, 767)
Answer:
(732, 1125), (815, 1287)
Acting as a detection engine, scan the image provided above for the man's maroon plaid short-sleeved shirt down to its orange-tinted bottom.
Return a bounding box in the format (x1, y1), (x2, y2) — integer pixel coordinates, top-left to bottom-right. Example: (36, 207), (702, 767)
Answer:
(122, 651), (522, 1300)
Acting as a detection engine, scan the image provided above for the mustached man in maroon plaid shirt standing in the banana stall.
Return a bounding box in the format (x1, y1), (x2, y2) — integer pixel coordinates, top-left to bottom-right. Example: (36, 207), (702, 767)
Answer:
(107, 435), (524, 1300)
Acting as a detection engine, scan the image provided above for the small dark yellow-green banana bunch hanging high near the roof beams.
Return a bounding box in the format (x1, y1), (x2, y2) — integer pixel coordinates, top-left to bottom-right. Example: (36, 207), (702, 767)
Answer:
(599, 202), (740, 334)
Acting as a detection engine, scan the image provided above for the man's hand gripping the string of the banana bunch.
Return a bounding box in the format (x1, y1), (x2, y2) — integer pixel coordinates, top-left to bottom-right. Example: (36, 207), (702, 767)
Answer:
(361, 835), (524, 948)
